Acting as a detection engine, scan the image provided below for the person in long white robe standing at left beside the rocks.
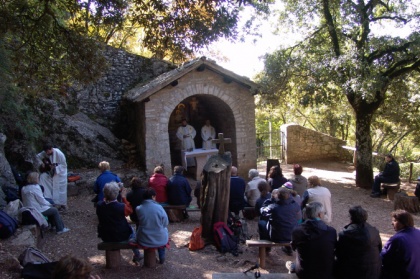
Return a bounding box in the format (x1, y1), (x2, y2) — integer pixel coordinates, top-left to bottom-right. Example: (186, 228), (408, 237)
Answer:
(36, 143), (67, 210)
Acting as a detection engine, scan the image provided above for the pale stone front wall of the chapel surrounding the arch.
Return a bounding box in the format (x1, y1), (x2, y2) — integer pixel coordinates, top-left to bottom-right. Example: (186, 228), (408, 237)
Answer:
(145, 70), (256, 177)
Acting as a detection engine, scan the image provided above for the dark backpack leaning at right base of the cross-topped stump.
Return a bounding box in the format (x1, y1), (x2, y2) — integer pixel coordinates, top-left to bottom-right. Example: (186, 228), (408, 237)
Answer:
(213, 222), (238, 256)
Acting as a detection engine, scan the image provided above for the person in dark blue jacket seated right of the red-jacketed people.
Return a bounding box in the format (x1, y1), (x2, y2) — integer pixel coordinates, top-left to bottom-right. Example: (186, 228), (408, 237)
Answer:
(166, 166), (192, 218)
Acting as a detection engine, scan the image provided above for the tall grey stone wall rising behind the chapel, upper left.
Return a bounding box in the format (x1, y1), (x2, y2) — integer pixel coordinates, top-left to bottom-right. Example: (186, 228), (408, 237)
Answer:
(70, 46), (176, 129)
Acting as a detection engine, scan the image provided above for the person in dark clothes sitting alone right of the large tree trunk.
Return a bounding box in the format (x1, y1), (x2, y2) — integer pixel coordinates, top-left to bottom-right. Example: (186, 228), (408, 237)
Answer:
(370, 154), (400, 198)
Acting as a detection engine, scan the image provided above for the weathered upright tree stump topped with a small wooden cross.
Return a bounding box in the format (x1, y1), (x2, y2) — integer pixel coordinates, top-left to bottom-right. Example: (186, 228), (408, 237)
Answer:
(200, 133), (232, 242)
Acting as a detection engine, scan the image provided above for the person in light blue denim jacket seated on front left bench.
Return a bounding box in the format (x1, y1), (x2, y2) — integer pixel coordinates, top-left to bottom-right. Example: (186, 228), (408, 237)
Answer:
(136, 188), (169, 264)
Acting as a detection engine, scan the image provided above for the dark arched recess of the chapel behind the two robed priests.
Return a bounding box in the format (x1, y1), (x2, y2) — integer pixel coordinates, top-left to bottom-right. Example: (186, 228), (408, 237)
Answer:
(168, 94), (237, 175)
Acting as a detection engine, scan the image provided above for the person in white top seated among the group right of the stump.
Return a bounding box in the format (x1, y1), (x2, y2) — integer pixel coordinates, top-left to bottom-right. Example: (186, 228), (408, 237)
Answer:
(302, 175), (332, 223)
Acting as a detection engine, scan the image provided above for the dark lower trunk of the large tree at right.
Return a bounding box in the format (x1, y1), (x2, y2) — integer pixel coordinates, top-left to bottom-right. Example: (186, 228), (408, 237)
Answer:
(355, 110), (373, 189)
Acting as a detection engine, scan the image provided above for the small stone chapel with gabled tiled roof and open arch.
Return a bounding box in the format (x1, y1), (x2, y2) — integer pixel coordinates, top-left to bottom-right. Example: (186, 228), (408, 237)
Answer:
(124, 57), (258, 178)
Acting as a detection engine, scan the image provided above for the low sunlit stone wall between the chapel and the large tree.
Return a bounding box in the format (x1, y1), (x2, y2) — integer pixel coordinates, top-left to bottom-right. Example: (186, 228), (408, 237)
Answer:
(281, 124), (351, 164)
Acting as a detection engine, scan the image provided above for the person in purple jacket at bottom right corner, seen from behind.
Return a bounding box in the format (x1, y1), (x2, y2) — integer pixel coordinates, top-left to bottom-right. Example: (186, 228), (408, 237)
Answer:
(381, 209), (420, 279)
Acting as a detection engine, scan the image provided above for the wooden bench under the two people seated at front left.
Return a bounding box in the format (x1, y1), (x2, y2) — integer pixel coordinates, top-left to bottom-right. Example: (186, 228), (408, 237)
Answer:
(98, 241), (157, 268)
